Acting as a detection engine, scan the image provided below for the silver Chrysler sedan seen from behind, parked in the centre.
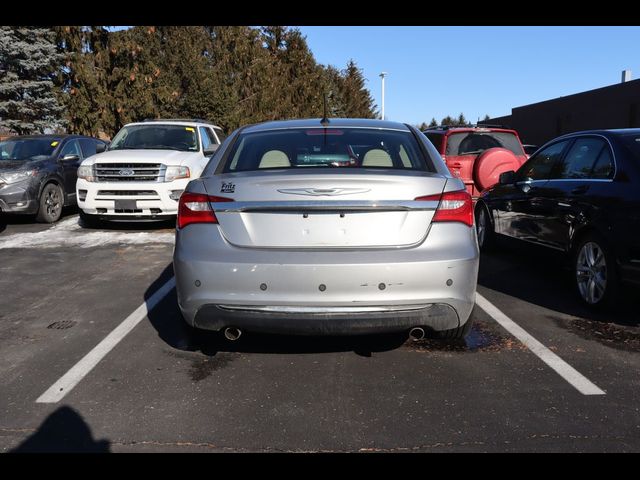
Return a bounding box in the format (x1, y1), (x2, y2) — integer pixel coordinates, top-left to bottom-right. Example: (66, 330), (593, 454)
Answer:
(173, 119), (479, 340)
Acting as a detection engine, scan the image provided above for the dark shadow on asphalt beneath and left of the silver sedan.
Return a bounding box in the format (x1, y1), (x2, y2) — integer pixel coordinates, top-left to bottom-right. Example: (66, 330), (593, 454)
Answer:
(145, 264), (407, 357)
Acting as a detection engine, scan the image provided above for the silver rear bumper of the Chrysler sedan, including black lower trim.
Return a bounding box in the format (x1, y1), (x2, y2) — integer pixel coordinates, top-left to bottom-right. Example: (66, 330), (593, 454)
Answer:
(173, 223), (478, 334)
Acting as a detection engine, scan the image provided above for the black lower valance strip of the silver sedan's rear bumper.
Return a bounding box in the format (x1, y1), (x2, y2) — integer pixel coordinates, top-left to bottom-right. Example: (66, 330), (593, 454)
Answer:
(194, 304), (460, 335)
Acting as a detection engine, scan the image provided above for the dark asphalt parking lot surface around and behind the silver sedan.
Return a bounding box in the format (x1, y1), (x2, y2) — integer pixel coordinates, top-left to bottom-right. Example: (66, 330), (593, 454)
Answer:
(0, 210), (640, 452)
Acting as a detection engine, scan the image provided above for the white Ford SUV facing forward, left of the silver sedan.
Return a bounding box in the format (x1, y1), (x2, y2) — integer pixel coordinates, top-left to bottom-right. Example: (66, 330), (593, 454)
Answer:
(76, 120), (224, 225)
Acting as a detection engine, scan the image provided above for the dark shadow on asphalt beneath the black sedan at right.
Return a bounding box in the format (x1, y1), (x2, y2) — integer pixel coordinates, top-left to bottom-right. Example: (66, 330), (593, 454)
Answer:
(478, 238), (640, 326)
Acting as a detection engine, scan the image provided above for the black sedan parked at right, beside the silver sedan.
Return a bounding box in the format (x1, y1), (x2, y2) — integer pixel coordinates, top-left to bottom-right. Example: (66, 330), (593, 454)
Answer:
(475, 129), (640, 306)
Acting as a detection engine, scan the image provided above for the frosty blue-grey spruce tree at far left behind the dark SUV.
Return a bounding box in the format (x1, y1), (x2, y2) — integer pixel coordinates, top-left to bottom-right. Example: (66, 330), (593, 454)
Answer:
(0, 26), (63, 135)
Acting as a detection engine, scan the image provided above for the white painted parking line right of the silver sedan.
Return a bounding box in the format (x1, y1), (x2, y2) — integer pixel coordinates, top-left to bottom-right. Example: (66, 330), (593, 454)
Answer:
(476, 293), (605, 395)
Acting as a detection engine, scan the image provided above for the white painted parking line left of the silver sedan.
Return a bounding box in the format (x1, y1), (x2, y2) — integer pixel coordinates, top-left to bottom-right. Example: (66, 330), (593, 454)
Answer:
(36, 277), (176, 403)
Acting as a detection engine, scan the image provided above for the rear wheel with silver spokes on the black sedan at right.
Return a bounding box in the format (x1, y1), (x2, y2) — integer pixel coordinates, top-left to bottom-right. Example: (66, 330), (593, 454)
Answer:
(572, 233), (620, 308)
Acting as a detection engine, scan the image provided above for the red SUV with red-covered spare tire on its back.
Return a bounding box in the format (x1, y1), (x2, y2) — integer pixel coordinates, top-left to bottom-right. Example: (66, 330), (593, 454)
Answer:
(423, 125), (527, 198)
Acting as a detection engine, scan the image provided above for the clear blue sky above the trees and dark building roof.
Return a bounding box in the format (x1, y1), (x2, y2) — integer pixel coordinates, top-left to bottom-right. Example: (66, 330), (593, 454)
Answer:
(298, 26), (640, 124)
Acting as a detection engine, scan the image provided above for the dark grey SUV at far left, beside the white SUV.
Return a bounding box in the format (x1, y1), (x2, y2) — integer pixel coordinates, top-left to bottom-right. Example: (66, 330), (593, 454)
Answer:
(0, 135), (107, 223)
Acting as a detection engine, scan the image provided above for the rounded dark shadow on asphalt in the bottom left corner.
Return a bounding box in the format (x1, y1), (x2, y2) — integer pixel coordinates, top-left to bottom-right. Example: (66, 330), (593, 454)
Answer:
(11, 407), (110, 453)
